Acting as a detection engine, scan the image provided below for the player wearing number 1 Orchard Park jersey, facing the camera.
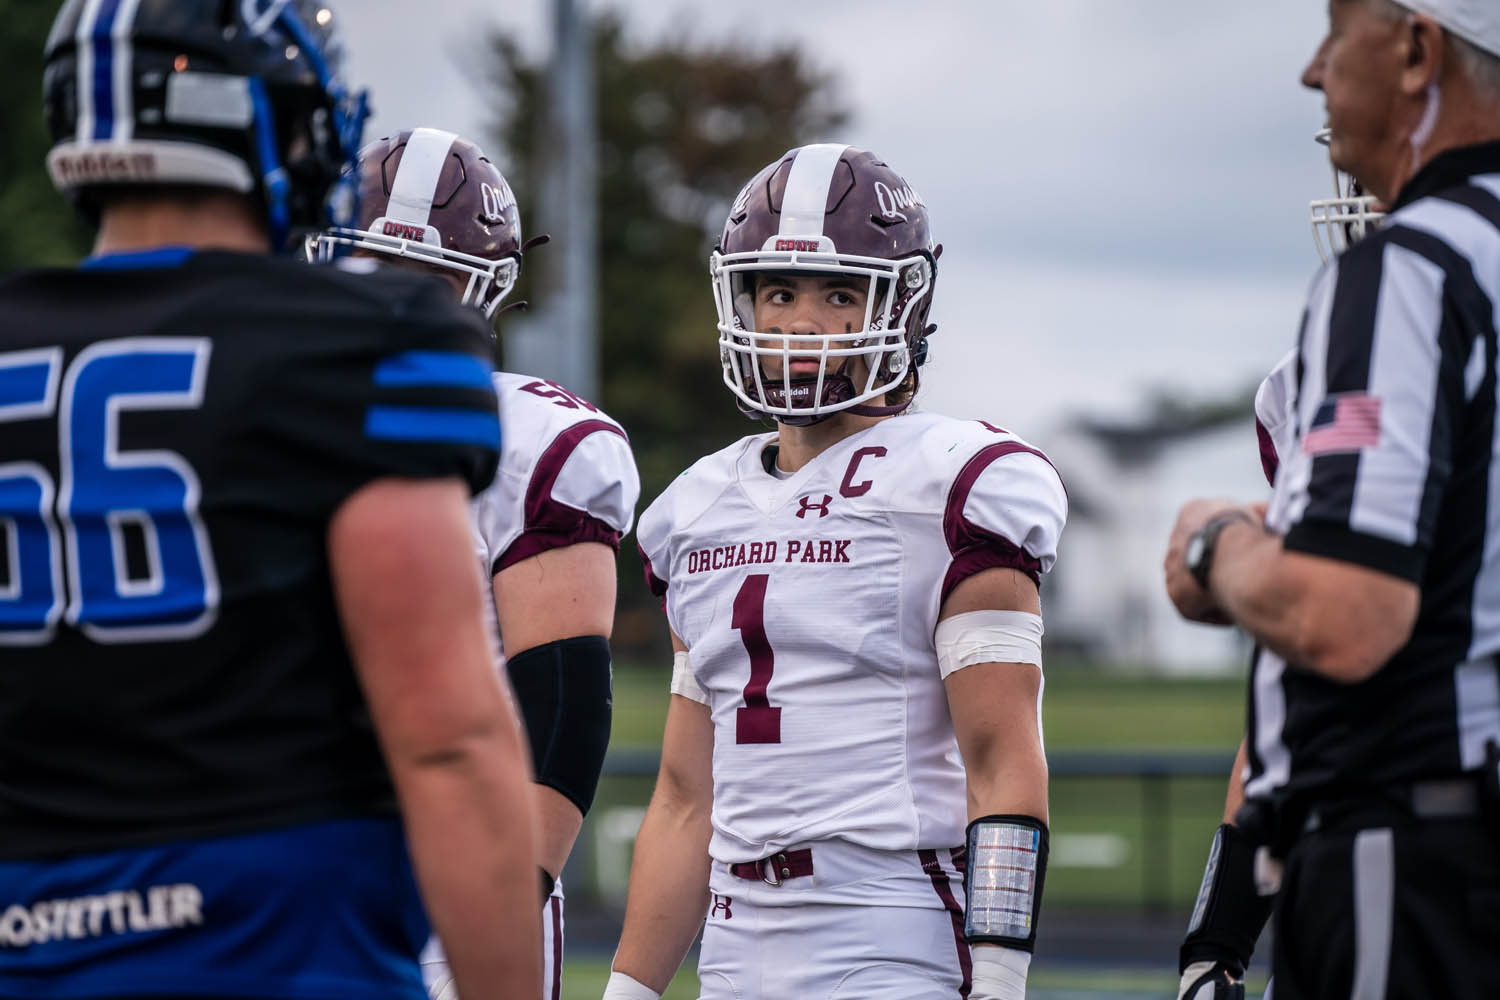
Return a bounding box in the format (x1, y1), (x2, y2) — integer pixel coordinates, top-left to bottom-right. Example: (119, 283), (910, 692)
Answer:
(605, 144), (1067, 1000)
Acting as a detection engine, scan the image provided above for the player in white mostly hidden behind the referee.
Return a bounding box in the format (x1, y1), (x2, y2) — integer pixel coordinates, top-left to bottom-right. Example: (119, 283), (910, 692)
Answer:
(1167, 129), (1385, 1000)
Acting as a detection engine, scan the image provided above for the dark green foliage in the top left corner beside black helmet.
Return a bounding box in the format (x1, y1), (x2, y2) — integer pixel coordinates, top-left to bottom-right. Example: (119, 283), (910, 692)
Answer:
(0, 0), (89, 273)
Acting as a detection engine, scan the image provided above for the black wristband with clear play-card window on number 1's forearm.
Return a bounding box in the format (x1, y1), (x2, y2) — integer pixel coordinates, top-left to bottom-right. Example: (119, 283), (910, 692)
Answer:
(963, 816), (1047, 952)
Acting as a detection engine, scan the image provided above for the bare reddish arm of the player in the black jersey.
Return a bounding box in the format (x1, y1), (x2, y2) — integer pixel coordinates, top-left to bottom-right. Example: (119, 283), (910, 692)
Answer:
(329, 480), (542, 1000)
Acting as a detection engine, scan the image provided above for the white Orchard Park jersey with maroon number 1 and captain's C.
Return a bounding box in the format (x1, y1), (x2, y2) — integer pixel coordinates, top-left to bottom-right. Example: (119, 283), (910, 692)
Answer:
(638, 412), (1067, 863)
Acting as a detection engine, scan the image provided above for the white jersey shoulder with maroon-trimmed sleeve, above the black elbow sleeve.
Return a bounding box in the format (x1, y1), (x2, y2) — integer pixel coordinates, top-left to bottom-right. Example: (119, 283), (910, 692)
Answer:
(470, 372), (641, 653)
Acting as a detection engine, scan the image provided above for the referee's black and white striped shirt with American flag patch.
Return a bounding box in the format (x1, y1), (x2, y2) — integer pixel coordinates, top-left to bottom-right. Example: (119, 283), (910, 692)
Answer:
(1245, 142), (1500, 799)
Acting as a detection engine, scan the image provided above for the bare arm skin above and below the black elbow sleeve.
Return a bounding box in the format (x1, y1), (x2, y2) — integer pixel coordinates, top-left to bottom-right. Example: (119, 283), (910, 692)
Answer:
(494, 541), (615, 879)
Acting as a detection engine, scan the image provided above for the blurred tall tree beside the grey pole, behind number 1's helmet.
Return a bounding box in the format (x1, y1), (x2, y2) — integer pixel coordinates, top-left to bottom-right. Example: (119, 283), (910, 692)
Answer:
(492, 13), (849, 656)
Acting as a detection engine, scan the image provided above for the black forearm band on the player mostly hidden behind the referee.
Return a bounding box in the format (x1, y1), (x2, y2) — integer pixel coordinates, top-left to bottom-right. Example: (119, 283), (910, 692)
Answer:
(1178, 823), (1275, 979)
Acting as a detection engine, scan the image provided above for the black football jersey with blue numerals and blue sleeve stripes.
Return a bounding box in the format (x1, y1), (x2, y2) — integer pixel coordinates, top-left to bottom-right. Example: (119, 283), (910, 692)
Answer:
(0, 252), (500, 858)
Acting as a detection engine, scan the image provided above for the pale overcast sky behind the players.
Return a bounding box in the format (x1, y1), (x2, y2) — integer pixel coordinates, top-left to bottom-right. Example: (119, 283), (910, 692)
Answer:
(338, 0), (1329, 436)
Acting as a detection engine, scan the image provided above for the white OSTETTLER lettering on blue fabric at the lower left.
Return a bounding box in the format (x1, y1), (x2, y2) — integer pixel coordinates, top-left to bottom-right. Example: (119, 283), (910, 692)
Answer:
(0, 882), (203, 949)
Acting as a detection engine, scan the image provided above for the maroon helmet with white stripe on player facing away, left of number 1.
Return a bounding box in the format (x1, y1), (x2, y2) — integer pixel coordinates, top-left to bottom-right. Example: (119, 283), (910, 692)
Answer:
(308, 129), (548, 316)
